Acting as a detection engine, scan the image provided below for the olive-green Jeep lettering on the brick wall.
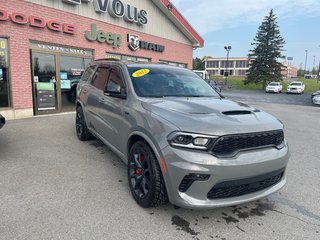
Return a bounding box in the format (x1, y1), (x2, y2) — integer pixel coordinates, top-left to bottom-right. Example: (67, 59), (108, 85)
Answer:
(84, 23), (122, 48)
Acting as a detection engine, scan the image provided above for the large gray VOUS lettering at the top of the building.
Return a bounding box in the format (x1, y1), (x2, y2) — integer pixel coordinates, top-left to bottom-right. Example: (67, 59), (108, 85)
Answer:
(62, 0), (148, 25)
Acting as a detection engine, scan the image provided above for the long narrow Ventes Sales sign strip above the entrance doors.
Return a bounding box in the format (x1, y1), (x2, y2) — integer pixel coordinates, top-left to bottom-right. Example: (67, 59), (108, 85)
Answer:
(30, 43), (93, 57)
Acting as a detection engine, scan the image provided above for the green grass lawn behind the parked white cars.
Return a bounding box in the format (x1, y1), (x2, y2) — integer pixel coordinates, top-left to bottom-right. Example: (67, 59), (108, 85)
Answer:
(211, 76), (320, 93)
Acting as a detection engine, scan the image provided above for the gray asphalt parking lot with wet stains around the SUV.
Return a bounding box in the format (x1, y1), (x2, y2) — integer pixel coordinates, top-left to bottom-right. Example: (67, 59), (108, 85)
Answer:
(0, 92), (320, 240)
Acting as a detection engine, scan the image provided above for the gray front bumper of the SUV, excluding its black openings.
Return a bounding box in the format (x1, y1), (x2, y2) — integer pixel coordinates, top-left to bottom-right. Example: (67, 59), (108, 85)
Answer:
(162, 143), (290, 209)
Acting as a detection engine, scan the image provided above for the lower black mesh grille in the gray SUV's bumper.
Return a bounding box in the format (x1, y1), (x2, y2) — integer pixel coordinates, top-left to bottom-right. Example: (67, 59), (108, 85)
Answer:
(207, 169), (284, 200)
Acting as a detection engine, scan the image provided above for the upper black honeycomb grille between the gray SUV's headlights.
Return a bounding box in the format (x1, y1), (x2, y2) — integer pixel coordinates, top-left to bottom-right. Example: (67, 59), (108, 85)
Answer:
(211, 130), (284, 156)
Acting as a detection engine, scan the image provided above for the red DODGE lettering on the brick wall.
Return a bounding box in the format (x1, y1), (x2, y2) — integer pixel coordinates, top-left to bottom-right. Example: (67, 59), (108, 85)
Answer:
(0, 9), (75, 34)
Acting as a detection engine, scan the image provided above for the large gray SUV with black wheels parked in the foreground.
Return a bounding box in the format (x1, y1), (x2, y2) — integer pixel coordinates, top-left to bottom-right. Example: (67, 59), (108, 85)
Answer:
(76, 60), (289, 208)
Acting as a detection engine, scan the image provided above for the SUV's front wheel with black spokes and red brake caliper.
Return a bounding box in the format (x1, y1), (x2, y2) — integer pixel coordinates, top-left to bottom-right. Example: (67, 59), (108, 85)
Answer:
(128, 141), (168, 208)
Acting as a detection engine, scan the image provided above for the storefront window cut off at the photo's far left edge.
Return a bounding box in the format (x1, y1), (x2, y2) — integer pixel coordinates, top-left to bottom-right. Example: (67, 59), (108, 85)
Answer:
(0, 38), (10, 108)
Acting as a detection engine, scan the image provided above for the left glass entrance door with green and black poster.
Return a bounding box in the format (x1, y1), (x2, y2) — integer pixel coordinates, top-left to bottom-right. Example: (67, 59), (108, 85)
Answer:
(32, 52), (58, 115)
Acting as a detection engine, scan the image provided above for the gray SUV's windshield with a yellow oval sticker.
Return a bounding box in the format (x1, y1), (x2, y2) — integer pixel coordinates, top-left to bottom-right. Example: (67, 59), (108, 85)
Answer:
(128, 65), (220, 97)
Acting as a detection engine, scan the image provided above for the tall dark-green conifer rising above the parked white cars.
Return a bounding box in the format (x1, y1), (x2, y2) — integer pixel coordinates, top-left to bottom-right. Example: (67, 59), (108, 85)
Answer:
(245, 10), (285, 89)
